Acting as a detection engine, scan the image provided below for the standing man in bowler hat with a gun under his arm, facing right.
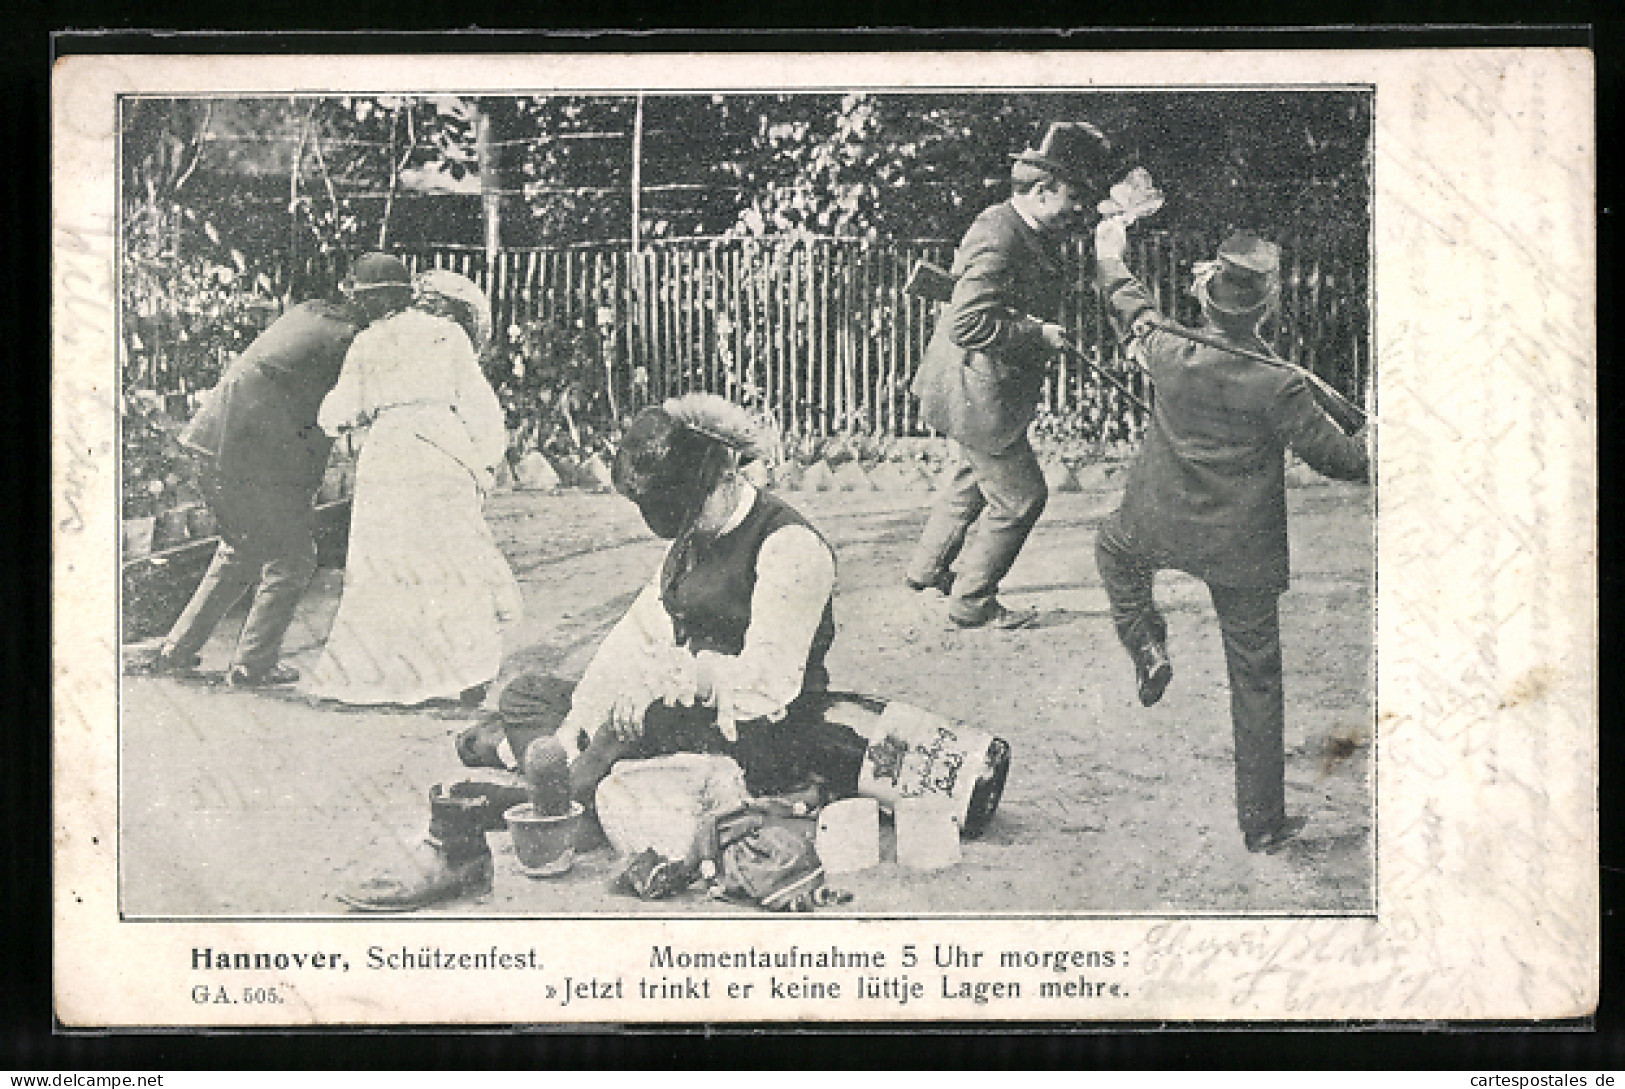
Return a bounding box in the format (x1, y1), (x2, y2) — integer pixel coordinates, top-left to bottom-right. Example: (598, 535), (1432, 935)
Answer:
(905, 122), (1110, 629)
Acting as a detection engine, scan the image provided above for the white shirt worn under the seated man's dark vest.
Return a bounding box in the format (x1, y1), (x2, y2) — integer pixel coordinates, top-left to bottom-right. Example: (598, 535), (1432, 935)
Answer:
(556, 481), (835, 759)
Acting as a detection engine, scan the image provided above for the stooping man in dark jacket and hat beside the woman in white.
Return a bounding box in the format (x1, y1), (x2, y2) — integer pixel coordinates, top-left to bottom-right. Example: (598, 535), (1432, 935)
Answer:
(153, 254), (411, 688)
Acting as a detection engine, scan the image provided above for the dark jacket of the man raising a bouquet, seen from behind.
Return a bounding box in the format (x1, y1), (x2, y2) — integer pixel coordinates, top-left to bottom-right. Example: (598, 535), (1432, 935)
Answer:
(1099, 260), (1370, 593)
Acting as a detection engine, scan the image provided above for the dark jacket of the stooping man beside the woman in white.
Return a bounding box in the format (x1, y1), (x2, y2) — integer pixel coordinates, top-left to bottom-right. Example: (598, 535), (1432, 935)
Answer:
(180, 301), (361, 492)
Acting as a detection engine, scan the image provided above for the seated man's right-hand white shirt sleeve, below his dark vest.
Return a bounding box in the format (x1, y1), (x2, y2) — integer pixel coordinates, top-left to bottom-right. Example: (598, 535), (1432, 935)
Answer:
(697, 525), (835, 740)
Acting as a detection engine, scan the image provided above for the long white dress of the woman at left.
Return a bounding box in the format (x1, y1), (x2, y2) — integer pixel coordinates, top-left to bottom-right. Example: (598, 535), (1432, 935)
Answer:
(306, 310), (520, 705)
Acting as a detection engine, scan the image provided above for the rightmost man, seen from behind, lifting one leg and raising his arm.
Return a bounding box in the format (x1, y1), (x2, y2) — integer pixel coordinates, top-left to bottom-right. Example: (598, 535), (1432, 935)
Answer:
(1095, 219), (1370, 852)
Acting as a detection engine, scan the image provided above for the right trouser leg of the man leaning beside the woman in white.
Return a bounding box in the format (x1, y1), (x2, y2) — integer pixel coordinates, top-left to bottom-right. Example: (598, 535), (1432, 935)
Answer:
(223, 484), (315, 676)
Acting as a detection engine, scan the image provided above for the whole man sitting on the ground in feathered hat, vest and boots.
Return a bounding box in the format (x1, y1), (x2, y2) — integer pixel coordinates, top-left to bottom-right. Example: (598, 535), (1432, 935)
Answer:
(340, 393), (1009, 910)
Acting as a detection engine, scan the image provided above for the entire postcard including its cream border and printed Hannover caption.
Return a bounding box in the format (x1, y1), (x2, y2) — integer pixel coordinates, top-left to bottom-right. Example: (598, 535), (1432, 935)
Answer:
(57, 46), (1596, 1022)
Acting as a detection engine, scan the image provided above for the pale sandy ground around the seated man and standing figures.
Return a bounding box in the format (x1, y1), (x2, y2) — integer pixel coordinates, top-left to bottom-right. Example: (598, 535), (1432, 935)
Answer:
(119, 484), (1375, 917)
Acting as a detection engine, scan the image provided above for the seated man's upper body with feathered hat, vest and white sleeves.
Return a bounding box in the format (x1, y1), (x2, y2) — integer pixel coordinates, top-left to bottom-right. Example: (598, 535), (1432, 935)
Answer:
(552, 393), (835, 806)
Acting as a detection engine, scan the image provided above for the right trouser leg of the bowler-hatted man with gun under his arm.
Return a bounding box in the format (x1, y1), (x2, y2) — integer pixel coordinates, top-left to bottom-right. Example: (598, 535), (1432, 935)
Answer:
(947, 436), (1050, 623)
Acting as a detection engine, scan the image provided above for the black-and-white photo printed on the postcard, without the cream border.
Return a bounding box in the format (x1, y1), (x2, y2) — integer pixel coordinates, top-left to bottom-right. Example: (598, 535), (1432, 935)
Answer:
(119, 88), (1376, 917)
